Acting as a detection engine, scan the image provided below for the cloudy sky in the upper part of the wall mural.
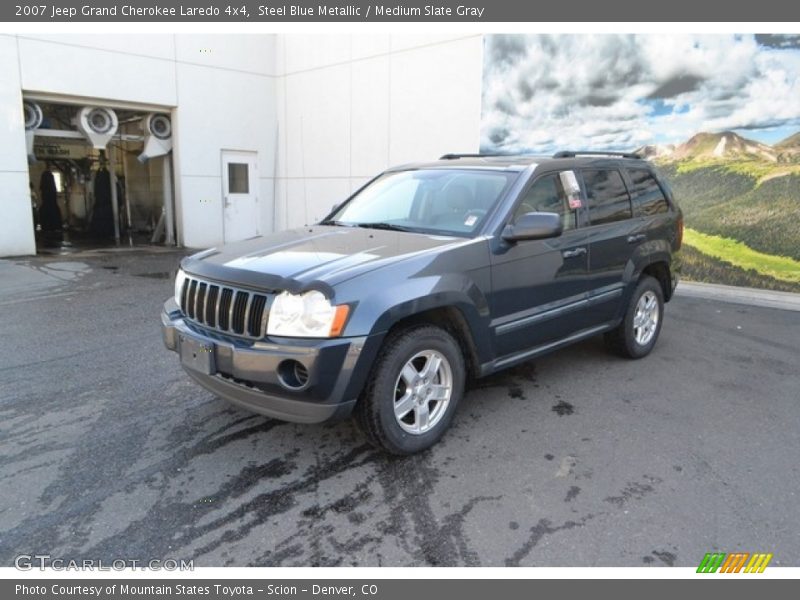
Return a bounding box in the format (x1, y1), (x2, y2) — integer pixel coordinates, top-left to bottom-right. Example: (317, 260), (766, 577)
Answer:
(481, 34), (800, 152)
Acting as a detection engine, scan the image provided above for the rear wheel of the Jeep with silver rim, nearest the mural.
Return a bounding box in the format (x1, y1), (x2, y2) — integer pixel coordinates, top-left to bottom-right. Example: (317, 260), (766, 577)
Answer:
(605, 275), (664, 358)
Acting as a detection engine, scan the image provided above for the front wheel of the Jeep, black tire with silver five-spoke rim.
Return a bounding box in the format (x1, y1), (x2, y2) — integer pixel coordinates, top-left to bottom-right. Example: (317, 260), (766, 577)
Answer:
(355, 325), (466, 455)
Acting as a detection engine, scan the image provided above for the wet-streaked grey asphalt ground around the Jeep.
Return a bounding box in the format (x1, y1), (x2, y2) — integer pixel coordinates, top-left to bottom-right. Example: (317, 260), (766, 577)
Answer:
(0, 251), (800, 566)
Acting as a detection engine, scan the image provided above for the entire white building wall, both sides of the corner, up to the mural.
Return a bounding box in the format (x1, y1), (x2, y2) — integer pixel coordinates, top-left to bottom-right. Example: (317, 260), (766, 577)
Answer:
(0, 34), (483, 256)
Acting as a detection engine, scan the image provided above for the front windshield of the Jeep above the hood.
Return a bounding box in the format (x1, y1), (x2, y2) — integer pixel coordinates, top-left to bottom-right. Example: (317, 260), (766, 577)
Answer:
(322, 169), (517, 236)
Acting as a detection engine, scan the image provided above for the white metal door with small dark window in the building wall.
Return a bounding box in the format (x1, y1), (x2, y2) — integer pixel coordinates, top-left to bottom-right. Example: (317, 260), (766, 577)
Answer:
(222, 150), (260, 243)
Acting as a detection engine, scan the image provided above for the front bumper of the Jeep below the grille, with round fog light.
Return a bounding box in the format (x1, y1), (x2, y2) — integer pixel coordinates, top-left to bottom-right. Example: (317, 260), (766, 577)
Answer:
(161, 299), (382, 423)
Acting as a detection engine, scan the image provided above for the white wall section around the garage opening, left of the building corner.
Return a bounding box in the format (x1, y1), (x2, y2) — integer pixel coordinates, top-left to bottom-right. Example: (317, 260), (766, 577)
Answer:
(0, 34), (276, 256)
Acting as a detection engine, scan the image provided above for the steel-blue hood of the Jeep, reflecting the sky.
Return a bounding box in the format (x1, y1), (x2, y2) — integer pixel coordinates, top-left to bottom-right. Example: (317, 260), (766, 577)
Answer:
(182, 225), (471, 291)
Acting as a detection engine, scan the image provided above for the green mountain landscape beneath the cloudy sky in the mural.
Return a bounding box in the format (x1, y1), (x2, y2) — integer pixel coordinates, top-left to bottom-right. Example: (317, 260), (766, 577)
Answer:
(636, 131), (800, 292)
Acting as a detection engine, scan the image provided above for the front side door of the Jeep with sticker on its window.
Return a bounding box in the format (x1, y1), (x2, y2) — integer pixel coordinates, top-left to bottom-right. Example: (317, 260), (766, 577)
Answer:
(492, 171), (589, 358)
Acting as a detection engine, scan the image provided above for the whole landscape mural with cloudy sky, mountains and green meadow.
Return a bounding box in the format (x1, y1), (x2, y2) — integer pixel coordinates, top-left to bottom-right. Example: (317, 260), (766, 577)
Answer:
(480, 34), (800, 292)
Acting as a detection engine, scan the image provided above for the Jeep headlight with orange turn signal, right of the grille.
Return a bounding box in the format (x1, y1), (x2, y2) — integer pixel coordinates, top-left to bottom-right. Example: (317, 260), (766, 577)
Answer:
(267, 290), (349, 337)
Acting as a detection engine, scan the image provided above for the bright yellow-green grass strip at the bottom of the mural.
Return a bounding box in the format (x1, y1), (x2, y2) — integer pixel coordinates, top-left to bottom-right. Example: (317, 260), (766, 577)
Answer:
(683, 228), (800, 283)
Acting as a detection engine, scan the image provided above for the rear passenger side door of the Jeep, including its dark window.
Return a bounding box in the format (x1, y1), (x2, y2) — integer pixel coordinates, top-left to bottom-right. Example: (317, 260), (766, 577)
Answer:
(581, 167), (646, 325)
